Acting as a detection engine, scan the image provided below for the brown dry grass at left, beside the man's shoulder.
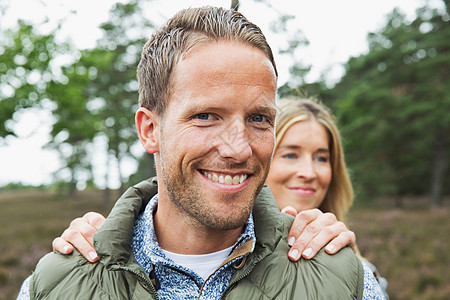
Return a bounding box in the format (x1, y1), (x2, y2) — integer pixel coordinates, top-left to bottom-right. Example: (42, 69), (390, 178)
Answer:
(0, 191), (113, 299)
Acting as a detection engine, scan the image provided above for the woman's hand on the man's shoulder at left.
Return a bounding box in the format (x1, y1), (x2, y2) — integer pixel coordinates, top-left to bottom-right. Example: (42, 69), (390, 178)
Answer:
(52, 212), (105, 262)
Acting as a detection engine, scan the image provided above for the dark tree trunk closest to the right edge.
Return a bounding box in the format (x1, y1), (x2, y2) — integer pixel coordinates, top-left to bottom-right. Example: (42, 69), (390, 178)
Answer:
(431, 128), (447, 207)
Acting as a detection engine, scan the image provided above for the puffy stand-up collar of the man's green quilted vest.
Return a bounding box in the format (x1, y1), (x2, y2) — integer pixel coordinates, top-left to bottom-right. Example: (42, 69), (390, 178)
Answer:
(94, 177), (282, 267)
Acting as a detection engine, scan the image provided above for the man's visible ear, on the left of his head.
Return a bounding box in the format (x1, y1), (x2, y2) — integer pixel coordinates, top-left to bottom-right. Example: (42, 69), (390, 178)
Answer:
(136, 107), (160, 153)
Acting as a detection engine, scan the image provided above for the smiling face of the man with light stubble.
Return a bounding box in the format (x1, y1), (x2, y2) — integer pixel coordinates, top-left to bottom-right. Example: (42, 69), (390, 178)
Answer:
(158, 41), (276, 230)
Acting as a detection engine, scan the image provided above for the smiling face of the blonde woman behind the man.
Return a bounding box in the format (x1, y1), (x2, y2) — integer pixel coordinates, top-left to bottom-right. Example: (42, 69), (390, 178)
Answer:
(266, 119), (332, 212)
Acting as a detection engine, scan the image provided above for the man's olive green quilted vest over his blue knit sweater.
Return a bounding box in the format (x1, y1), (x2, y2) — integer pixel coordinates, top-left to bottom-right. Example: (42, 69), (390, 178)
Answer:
(30, 178), (364, 300)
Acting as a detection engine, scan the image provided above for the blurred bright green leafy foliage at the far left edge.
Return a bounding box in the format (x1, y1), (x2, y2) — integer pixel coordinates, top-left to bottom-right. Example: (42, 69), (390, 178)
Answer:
(0, 20), (67, 143)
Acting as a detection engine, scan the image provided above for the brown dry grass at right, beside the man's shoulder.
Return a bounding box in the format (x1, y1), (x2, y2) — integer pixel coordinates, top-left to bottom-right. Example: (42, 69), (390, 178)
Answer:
(349, 201), (450, 300)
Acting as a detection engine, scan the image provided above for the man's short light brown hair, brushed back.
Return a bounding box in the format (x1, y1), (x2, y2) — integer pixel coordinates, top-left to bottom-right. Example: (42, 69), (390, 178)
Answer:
(137, 6), (278, 115)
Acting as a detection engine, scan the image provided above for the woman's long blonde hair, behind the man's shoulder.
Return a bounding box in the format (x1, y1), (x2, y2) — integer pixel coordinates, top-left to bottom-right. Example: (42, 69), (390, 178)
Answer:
(275, 99), (354, 222)
